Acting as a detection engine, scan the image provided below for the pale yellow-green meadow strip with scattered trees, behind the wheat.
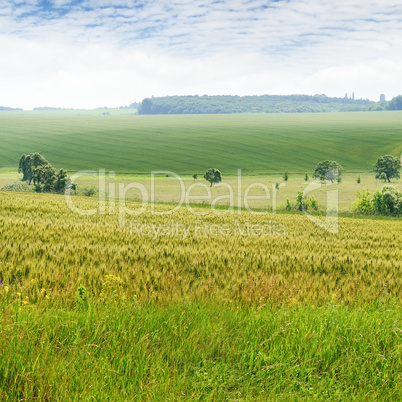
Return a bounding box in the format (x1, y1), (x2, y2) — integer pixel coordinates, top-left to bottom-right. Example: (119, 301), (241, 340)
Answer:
(0, 170), (396, 213)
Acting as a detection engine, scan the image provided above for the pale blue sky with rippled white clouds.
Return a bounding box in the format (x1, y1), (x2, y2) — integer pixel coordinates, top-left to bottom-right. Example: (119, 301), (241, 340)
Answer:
(0, 0), (402, 110)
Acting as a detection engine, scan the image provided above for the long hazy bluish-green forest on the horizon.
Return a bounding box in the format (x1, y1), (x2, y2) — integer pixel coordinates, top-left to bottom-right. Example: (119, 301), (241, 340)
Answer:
(138, 95), (387, 114)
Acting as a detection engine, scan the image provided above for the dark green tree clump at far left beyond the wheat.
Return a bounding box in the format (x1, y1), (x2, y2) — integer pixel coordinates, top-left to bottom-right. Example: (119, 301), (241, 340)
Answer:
(18, 153), (76, 194)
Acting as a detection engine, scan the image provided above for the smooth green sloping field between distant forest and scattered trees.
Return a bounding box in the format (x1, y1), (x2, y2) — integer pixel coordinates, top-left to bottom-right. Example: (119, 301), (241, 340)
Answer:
(0, 112), (402, 175)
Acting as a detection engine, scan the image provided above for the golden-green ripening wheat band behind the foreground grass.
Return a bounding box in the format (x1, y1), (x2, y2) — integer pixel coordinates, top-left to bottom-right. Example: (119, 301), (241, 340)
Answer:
(0, 192), (402, 306)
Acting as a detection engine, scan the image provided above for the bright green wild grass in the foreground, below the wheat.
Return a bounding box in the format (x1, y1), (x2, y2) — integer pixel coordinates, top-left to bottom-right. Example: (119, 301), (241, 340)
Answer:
(0, 303), (402, 401)
